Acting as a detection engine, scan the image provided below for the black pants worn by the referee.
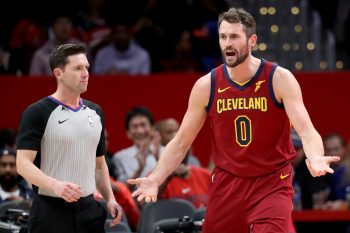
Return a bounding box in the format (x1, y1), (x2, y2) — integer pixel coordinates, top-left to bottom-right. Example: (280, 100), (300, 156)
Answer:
(28, 194), (107, 233)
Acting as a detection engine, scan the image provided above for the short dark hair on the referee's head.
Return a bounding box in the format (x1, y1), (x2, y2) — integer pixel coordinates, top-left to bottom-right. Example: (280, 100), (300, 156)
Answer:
(49, 44), (86, 71)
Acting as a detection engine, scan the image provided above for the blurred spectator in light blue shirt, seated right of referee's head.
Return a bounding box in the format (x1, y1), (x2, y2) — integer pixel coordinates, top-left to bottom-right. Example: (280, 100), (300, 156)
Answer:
(93, 23), (151, 75)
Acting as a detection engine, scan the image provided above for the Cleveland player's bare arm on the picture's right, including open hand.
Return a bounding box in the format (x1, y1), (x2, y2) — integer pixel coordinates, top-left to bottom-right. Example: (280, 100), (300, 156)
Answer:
(273, 67), (340, 176)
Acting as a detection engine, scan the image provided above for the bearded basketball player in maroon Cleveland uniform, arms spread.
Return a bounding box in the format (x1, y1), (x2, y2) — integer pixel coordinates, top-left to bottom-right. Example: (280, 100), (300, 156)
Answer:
(129, 8), (339, 233)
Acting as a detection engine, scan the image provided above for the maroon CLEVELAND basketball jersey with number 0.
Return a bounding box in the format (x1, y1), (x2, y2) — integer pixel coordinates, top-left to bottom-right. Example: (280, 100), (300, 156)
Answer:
(207, 59), (295, 177)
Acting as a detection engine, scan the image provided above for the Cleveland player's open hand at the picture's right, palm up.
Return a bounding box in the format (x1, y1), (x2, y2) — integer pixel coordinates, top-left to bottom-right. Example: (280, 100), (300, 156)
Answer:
(305, 156), (340, 177)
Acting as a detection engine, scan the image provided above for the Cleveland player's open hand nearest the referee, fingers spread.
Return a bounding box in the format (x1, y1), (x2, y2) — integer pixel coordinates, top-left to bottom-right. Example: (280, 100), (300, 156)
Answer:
(127, 177), (158, 202)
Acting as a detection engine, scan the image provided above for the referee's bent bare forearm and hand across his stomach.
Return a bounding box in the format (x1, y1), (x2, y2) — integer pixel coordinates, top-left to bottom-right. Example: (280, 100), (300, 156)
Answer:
(16, 150), (82, 202)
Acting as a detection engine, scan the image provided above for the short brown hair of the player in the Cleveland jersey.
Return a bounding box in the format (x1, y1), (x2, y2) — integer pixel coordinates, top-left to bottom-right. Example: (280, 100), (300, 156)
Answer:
(218, 7), (256, 37)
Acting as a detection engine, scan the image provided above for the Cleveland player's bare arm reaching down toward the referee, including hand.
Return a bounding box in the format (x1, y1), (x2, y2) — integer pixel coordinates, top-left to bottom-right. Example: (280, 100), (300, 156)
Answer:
(128, 74), (210, 202)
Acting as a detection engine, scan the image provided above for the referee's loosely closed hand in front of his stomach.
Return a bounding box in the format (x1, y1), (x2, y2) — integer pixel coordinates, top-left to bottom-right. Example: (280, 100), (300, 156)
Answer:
(53, 181), (83, 202)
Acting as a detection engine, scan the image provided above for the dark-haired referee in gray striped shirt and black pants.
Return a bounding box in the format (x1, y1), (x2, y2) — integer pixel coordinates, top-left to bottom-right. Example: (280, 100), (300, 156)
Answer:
(17, 44), (122, 233)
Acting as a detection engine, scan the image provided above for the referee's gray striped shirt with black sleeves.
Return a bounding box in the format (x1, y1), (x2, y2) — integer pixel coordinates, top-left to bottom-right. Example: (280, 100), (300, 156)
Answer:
(17, 96), (105, 197)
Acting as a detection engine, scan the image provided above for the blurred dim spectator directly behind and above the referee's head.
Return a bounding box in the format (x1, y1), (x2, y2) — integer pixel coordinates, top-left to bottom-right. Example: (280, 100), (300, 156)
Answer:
(29, 15), (81, 76)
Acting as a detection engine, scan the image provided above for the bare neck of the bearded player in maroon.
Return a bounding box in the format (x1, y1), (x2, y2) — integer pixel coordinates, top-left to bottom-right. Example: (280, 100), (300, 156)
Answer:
(227, 55), (261, 83)
